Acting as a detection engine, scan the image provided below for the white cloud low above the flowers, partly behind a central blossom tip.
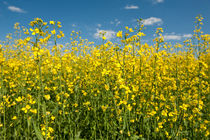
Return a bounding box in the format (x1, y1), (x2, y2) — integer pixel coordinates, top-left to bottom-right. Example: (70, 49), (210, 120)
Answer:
(94, 29), (116, 39)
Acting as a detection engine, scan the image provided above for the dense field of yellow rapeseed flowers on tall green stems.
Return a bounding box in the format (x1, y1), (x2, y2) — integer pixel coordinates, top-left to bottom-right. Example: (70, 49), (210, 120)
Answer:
(0, 16), (210, 140)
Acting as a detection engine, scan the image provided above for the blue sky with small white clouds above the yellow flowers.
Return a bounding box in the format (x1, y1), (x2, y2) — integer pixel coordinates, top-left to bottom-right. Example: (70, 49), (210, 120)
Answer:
(0, 0), (210, 42)
